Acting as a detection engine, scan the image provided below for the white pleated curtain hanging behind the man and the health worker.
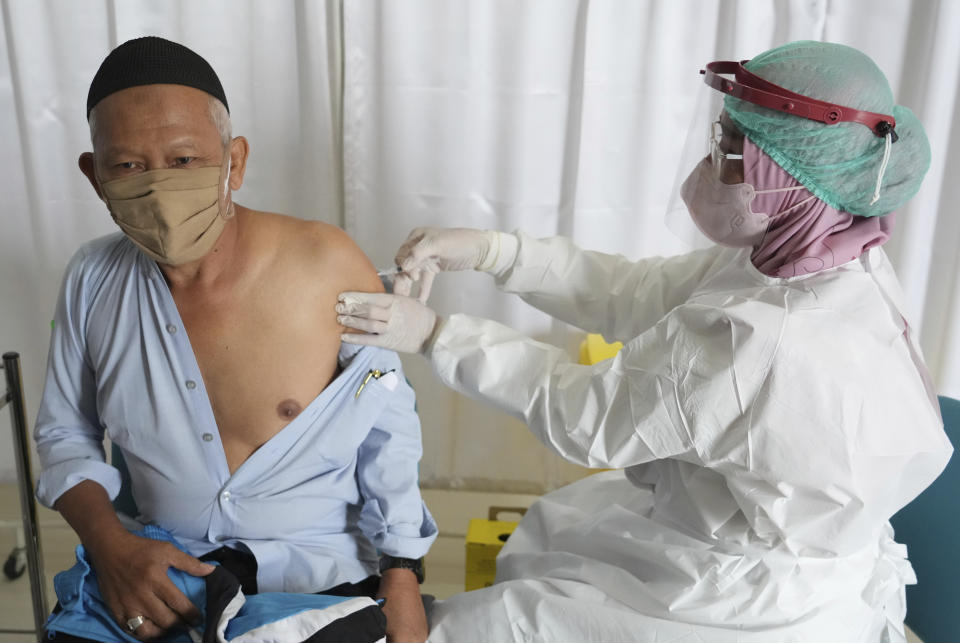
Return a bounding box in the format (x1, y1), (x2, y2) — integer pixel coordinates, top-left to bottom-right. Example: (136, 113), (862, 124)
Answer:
(0, 0), (960, 492)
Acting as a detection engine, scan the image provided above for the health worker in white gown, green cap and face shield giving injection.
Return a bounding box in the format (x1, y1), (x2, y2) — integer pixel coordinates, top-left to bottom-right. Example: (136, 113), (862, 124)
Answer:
(338, 42), (952, 643)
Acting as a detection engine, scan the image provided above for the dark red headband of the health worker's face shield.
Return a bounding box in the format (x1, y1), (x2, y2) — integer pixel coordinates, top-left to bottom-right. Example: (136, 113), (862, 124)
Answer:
(700, 60), (897, 143)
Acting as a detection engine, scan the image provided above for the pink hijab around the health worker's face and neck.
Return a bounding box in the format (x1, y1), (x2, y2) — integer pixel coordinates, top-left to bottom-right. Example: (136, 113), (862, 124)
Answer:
(743, 137), (894, 277)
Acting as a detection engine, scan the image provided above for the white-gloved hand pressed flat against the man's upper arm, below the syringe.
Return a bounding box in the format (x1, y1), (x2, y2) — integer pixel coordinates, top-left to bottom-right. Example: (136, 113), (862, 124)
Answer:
(337, 292), (437, 353)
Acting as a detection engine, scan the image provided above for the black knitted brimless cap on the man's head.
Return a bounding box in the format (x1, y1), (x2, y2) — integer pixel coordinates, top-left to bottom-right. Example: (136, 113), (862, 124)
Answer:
(87, 36), (230, 118)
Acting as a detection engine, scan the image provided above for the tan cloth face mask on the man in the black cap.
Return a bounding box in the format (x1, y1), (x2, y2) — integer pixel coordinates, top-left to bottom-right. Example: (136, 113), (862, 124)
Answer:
(101, 162), (230, 266)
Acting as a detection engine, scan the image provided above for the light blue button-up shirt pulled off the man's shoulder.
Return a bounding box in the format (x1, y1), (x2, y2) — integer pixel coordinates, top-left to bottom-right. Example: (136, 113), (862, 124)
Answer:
(34, 233), (437, 592)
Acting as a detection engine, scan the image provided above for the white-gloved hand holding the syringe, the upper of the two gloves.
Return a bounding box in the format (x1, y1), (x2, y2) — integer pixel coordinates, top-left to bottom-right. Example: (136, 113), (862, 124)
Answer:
(393, 228), (518, 302)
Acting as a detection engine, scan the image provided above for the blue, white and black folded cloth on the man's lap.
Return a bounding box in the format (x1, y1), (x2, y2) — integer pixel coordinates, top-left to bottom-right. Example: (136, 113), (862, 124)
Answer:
(46, 525), (386, 643)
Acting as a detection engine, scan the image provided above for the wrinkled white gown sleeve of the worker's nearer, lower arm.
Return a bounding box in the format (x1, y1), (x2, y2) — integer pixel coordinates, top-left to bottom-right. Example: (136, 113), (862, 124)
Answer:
(427, 296), (752, 468)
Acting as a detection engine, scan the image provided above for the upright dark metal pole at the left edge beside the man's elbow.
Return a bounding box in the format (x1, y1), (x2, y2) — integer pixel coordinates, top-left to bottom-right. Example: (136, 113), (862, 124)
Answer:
(3, 352), (48, 641)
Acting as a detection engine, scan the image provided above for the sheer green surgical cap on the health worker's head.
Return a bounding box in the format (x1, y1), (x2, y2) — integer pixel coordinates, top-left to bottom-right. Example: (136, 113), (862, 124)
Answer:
(724, 40), (930, 217)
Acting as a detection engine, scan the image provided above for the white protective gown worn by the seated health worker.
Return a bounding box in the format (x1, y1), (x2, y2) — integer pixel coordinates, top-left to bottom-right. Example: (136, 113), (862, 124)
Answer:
(428, 233), (952, 643)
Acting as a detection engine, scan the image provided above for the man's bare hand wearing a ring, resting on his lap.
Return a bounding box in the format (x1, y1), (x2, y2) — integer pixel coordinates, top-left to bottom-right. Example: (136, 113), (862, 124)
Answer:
(87, 533), (214, 640)
